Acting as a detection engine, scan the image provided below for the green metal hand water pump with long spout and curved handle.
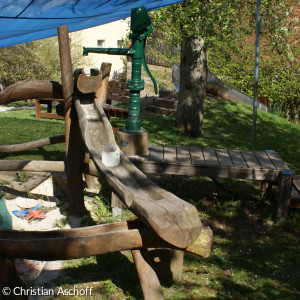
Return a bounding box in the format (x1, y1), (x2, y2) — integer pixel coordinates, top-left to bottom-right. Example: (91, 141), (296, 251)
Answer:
(83, 6), (157, 132)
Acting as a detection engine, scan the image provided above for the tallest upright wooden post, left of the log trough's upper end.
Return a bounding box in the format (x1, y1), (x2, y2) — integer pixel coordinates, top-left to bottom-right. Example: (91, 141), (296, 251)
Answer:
(58, 26), (85, 215)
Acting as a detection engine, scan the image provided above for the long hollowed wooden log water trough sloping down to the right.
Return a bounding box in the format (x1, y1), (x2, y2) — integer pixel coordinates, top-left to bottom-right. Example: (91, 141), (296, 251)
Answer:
(75, 74), (201, 248)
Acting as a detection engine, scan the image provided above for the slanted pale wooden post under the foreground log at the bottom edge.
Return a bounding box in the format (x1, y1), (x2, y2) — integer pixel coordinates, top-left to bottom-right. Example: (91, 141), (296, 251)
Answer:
(132, 249), (164, 300)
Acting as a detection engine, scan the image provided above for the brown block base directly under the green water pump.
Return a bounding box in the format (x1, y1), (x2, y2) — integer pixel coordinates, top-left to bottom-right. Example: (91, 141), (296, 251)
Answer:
(117, 131), (148, 156)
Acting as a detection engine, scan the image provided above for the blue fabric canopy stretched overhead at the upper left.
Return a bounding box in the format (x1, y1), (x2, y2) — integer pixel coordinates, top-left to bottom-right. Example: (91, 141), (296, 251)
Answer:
(0, 0), (182, 48)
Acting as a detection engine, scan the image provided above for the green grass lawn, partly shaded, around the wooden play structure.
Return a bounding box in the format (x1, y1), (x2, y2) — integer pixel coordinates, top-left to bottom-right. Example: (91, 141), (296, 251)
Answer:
(0, 98), (300, 300)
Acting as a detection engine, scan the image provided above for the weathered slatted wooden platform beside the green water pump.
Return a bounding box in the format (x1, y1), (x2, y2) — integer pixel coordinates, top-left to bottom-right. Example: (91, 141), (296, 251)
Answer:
(129, 146), (293, 220)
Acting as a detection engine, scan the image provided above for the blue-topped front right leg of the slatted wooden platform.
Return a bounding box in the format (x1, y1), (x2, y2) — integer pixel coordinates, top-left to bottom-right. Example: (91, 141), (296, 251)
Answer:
(277, 170), (293, 222)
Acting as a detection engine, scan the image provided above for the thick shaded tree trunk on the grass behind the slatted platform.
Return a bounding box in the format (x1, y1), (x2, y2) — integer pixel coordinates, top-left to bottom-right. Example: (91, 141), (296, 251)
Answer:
(176, 38), (207, 137)
